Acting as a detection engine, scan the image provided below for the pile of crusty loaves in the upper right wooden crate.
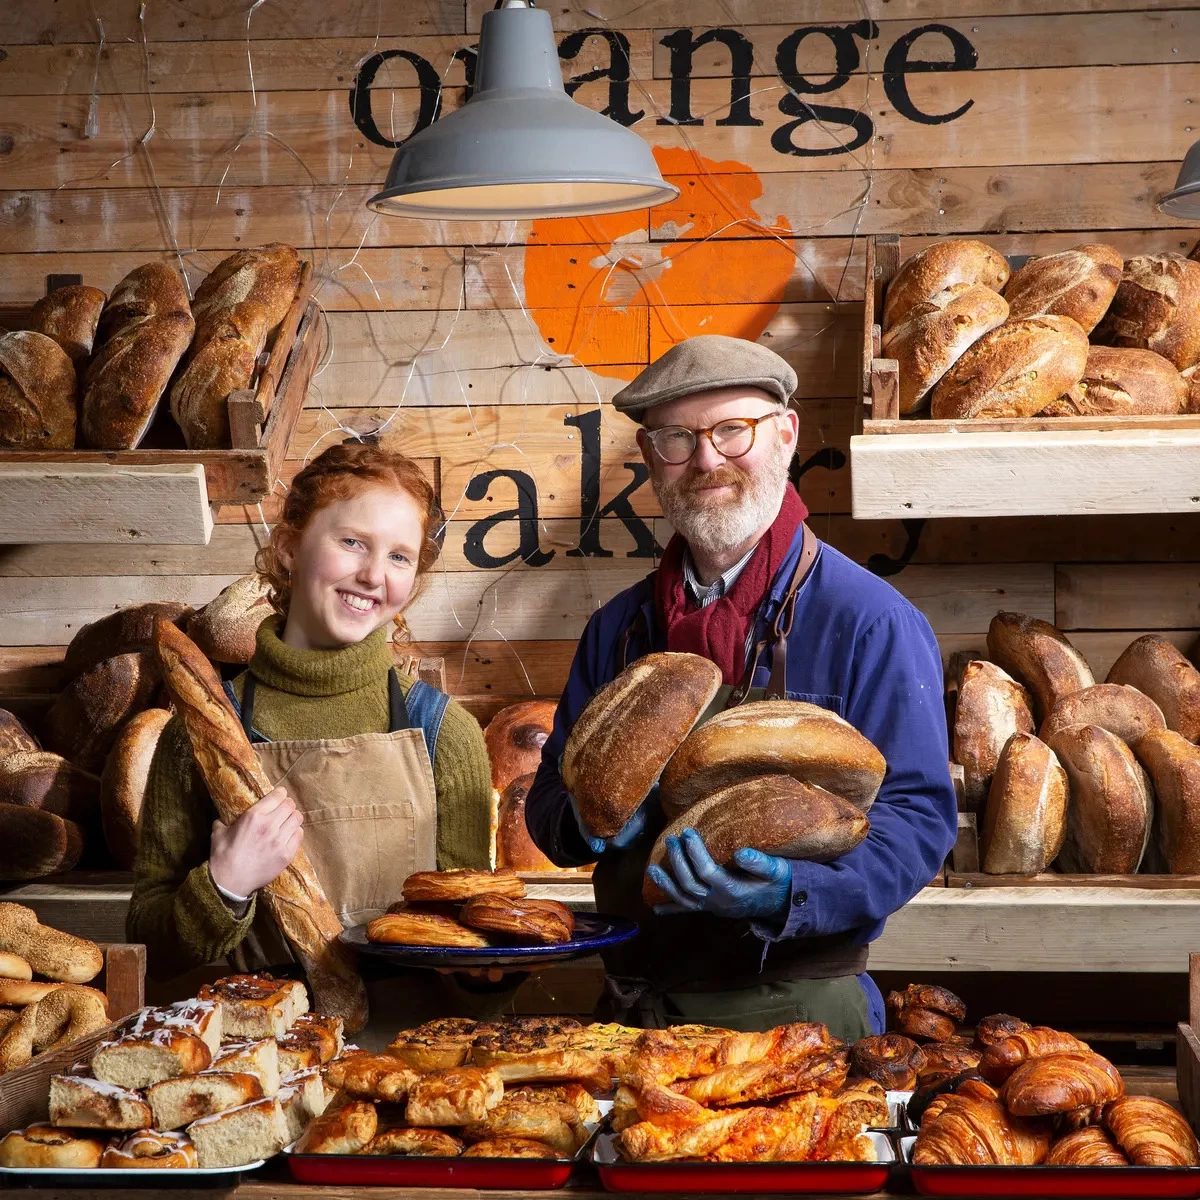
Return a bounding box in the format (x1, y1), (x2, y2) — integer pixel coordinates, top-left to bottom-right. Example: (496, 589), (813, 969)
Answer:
(881, 240), (1200, 420)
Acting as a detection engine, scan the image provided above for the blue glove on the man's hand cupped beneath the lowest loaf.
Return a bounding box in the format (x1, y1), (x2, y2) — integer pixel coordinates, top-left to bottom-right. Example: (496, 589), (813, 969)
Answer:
(648, 828), (792, 920)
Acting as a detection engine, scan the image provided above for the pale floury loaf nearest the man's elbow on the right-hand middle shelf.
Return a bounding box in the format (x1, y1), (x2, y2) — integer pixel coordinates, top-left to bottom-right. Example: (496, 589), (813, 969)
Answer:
(952, 659), (1033, 812)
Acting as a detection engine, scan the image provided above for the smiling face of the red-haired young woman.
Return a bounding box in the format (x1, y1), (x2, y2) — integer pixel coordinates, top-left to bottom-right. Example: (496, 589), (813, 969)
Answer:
(280, 485), (424, 650)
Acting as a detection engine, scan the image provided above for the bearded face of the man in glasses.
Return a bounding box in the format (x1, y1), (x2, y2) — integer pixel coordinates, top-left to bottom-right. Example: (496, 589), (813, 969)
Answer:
(637, 388), (799, 553)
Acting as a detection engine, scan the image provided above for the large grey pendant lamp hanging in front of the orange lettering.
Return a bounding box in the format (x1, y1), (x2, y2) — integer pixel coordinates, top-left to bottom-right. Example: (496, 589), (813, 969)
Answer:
(367, 0), (679, 221)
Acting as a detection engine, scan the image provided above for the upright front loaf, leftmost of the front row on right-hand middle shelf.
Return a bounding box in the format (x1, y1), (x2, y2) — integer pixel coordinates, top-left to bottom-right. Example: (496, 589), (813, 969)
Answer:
(979, 733), (1067, 875)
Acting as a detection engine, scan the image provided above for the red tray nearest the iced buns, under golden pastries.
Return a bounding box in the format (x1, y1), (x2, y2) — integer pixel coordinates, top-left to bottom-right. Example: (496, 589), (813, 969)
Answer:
(284, 1154), (576, 1192)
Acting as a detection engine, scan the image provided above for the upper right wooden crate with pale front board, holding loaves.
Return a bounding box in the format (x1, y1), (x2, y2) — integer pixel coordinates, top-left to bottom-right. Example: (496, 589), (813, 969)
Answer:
(850, 234), (1200, 518)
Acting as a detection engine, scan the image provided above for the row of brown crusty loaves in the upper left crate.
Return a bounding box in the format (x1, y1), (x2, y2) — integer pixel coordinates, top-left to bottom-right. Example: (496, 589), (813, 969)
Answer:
(0, 242), (300, 450)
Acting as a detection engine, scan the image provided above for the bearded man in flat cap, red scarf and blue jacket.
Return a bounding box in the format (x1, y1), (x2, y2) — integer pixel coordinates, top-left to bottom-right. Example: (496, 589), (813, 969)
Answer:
(526, 336), (956, 1040)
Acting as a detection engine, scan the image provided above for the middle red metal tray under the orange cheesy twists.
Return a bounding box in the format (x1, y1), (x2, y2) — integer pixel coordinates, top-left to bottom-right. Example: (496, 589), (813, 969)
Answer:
(592, 1132), (896, 1195)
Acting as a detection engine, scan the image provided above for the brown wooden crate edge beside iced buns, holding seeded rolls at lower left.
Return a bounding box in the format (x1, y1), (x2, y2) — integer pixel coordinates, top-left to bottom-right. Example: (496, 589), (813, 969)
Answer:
(0, 943), (146, 1134)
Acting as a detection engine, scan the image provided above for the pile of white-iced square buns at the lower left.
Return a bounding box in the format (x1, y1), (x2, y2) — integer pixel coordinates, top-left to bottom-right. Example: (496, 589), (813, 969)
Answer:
(0, 974), (347, 1169)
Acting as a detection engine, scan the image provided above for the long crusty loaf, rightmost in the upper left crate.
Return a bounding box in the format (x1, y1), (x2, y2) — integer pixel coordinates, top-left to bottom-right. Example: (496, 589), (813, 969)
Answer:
(170, 242), (300, 449)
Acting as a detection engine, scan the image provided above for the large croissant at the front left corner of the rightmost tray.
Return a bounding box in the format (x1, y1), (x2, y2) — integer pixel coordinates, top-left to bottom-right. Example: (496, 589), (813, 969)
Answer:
(912, 1096), (1050, 1166)
